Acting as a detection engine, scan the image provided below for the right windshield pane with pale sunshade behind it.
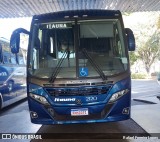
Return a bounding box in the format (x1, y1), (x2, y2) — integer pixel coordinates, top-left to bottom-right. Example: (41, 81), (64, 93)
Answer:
(79, 21), (128, 76)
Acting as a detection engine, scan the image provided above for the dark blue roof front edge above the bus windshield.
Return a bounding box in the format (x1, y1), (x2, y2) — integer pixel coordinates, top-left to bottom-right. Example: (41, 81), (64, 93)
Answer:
(33, 9), (121, 20)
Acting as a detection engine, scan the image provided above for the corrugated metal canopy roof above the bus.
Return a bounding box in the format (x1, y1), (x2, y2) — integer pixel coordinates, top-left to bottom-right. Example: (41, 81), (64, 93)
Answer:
(0, 0), (160, 18)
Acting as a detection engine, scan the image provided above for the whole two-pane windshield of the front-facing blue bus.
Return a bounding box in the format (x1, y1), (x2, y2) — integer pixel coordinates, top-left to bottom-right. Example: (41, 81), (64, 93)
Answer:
(29, 19), (128, 79)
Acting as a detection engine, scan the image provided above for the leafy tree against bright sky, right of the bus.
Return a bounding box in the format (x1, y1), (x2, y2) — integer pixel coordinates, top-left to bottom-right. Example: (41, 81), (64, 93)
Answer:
(123, 12), (160, 74)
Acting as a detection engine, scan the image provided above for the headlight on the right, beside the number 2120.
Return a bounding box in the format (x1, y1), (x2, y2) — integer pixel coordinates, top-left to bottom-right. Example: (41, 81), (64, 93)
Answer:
(109, 89), (129, 103)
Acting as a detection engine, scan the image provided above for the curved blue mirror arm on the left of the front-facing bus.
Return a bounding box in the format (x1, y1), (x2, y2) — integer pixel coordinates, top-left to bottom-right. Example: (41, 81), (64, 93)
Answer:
(10, 28), (30, 54)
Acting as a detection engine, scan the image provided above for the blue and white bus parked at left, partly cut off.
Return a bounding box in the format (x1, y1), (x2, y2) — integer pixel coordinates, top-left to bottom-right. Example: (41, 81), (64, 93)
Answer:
(0, 38), (27, 108)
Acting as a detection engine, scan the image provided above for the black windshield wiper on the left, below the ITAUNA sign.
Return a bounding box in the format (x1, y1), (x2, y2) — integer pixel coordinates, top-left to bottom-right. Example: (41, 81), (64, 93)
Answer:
(49, 51), (67, 83)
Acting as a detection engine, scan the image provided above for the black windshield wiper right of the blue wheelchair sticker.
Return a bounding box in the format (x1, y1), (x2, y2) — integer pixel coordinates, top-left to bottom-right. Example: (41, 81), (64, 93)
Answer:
(82, 48), (107, 81)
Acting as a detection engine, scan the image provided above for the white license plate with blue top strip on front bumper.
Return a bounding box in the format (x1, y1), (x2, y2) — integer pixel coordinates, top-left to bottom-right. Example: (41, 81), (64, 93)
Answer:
(71, 108), (88, 116)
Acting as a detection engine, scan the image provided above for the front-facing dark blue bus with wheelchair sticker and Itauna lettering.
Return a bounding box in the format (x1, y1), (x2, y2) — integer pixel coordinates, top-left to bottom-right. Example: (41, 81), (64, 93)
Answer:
(10, 10), (135, 124)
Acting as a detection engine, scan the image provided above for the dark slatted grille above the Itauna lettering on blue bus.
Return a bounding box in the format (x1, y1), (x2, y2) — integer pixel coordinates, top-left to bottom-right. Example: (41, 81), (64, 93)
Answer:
(45, 85), (111, 96)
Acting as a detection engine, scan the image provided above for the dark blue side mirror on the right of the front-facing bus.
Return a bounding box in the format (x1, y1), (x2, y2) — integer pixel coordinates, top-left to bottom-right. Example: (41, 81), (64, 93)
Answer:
(125, 28), (135, 51)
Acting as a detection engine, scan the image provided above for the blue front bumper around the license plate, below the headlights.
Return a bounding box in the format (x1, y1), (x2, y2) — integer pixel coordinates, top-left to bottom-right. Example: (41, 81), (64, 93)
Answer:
(28, 95), (130, 124)
